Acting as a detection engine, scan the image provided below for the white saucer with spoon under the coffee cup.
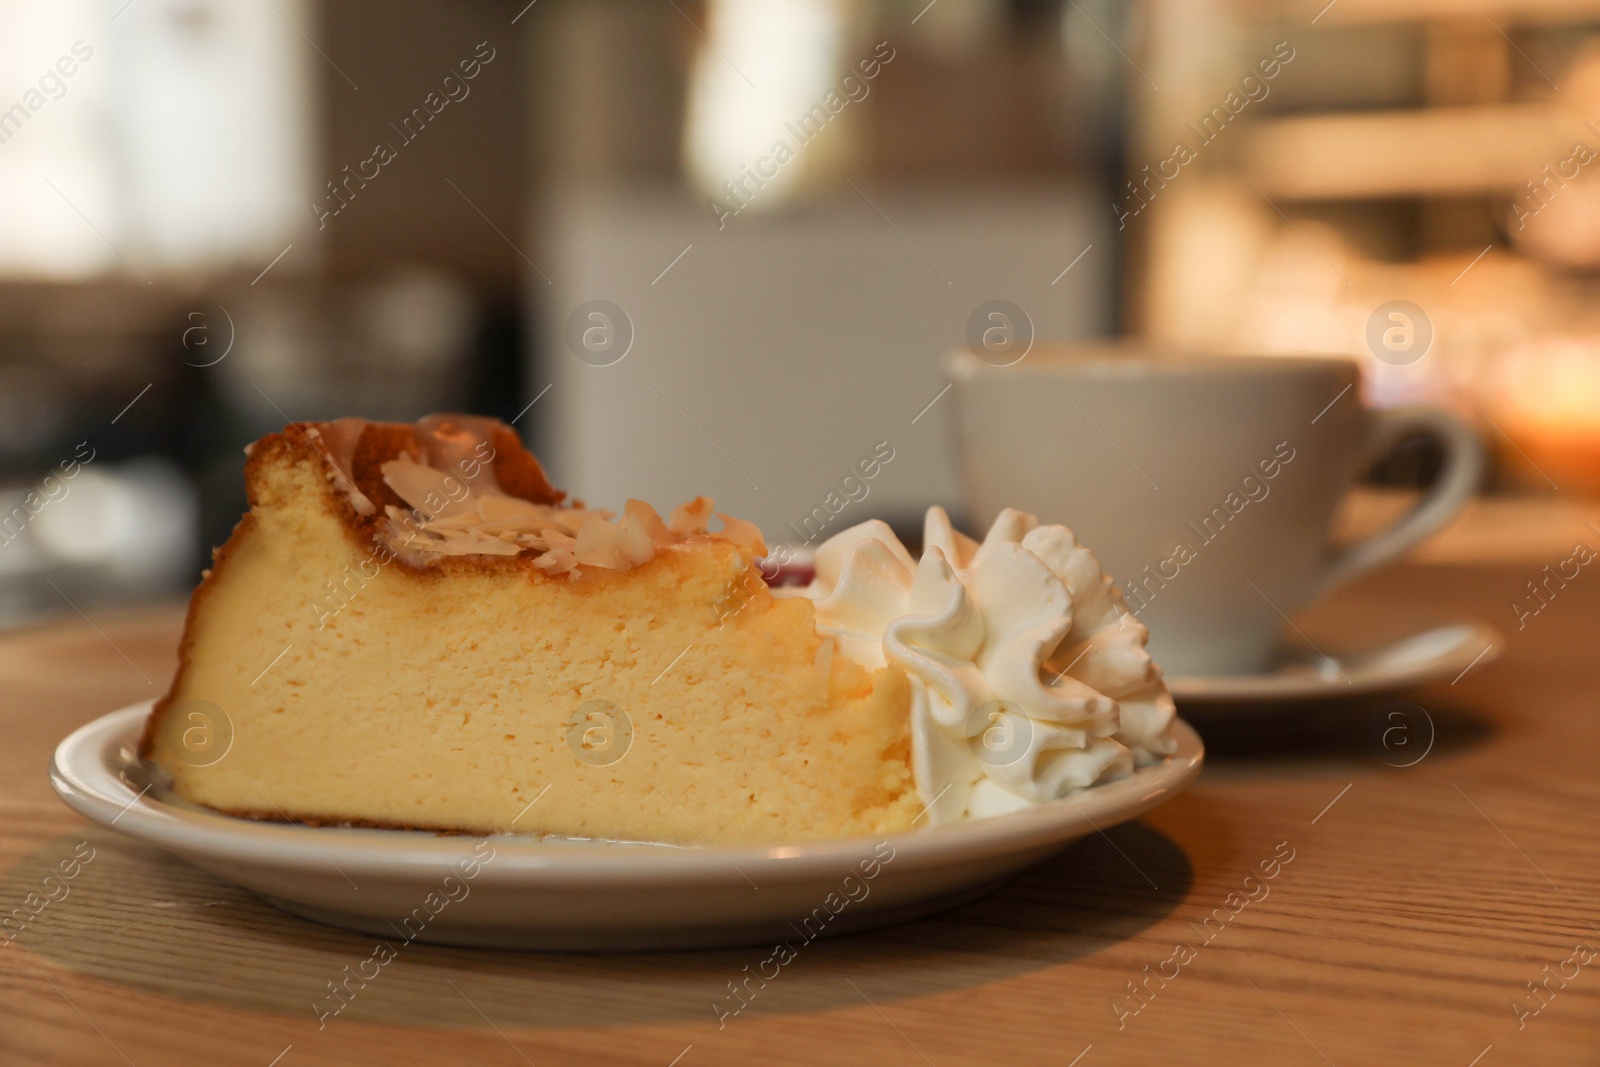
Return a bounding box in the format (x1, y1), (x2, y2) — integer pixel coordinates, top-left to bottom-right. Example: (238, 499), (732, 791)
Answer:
(1166, 617), (1506, 705)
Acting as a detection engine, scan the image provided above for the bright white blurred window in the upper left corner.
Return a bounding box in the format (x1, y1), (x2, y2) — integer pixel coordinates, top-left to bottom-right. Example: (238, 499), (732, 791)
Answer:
(0, 0), (314, 280)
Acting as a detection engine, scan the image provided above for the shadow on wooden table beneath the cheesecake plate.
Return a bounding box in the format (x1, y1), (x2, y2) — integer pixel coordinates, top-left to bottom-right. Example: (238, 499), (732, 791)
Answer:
(0, 822), (1194, 1027)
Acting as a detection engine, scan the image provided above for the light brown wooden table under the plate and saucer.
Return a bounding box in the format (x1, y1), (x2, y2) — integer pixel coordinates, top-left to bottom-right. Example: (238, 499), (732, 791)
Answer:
(0, 559), (1600, 1067)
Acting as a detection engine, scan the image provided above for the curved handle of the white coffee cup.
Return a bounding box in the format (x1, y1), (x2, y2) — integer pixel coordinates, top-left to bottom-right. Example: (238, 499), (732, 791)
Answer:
(1317, 406), (1483, 597)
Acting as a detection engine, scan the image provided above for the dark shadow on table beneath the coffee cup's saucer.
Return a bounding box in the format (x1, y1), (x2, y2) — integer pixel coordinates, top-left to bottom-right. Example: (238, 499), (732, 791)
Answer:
(1178, 693), (1496, 769)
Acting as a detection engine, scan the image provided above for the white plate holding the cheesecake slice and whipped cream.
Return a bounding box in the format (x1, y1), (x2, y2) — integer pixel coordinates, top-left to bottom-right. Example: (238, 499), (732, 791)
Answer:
(50, 702), (1202, 950)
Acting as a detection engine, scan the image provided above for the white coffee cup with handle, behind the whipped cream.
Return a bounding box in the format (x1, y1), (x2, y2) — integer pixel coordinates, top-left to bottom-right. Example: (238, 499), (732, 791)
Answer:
(947, 344), (1483, 675)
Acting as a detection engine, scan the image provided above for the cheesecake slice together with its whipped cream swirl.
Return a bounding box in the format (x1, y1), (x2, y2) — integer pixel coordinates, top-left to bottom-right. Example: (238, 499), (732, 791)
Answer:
(141, 414), (1173, 845)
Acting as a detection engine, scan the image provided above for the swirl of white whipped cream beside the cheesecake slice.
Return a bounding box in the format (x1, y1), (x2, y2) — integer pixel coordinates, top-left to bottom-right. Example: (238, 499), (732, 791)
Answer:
(774, 507), (1176, 825)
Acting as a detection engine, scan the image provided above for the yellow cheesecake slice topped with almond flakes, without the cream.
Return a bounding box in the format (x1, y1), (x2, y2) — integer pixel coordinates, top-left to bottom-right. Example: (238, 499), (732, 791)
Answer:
(141, 416), (922, 843)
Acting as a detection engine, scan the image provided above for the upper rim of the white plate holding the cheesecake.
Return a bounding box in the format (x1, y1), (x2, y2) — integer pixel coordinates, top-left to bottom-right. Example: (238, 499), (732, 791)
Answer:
(50, 701), (1205, 888)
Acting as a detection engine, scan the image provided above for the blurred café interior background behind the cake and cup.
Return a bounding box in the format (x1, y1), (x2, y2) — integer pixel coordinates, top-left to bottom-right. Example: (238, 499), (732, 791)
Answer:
(0, 0), (1600, 625)
